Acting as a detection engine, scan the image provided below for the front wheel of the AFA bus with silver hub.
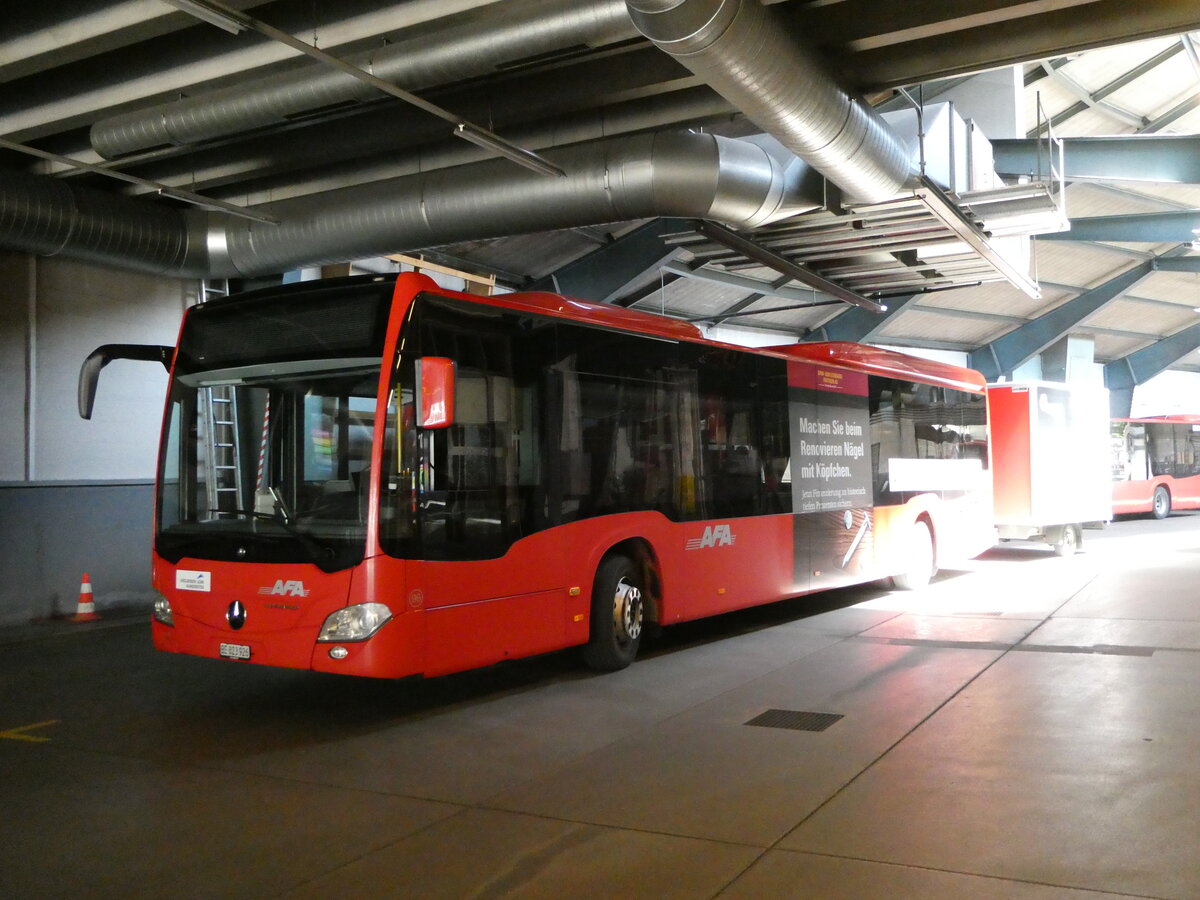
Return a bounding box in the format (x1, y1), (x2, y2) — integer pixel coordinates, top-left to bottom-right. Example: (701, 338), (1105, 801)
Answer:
(583, 553), (644, 672)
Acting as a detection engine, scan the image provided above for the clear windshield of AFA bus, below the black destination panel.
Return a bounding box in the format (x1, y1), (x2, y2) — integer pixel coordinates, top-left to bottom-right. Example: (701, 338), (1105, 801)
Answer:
(157, 360), (379, 571)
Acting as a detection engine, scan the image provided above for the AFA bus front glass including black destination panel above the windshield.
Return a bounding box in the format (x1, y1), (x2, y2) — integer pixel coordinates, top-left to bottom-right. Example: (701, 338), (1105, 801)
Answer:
(155, 281), (391, 571)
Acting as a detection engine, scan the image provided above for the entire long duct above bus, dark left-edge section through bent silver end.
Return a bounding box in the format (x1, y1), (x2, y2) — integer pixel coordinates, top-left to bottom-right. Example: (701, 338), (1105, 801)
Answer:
(0, 132), (820, 277)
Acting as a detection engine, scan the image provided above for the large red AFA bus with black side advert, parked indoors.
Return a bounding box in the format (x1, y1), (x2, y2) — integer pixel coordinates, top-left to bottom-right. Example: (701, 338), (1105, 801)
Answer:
(80, 274), (995, 678)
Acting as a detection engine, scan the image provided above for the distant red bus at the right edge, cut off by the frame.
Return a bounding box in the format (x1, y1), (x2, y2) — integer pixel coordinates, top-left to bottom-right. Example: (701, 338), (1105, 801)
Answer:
(1111, 415), (1200, 518)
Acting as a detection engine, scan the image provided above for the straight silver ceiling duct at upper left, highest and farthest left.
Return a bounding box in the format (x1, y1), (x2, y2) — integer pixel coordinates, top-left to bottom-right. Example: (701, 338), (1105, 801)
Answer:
(91, 0), (637, 160)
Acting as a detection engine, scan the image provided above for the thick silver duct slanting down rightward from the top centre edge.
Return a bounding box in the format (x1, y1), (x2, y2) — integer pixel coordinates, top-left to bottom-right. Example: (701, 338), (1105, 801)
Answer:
(626, 0), (911, 202)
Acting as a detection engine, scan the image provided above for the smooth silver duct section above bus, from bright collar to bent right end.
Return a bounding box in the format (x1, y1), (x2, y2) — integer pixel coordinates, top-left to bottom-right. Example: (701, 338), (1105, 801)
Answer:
(213, 132), (817, 275)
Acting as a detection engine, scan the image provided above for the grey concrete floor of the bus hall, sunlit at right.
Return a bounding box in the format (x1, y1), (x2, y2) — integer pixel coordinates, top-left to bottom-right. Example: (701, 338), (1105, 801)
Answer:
(0, 514), (1200, 900)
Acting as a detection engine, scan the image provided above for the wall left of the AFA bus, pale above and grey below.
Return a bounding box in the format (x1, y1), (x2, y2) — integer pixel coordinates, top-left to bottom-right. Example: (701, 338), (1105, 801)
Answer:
(0, 253), (189, 624)
